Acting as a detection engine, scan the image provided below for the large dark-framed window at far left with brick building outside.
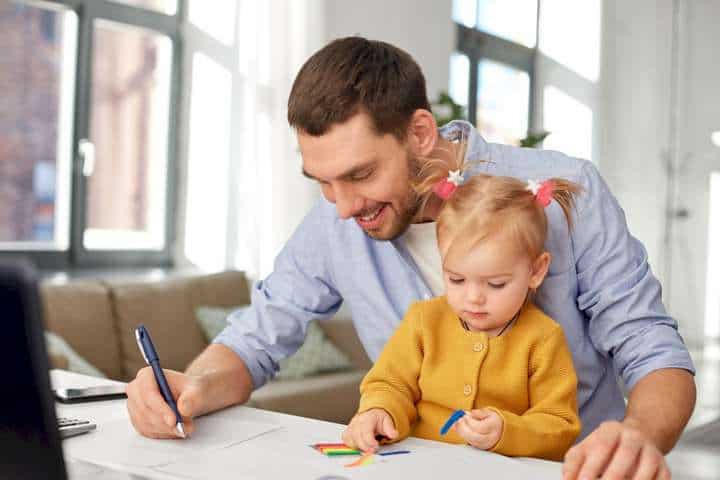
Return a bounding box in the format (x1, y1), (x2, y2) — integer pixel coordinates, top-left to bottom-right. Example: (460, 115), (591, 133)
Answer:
(0, 0), (184, 269)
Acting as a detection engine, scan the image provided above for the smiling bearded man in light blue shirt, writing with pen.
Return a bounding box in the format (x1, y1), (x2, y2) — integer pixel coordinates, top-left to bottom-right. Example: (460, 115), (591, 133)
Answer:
(128, 37), (695, 479)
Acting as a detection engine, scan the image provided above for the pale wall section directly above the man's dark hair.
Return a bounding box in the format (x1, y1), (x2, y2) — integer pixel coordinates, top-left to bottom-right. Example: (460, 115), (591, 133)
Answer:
(325, 0), (455, 101)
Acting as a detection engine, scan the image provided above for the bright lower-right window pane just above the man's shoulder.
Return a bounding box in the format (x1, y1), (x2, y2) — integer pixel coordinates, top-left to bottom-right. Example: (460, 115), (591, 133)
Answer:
(543, 86), (593, 160)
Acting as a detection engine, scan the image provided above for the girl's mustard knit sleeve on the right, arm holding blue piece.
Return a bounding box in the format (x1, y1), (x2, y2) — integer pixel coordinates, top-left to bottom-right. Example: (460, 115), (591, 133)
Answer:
(489, 326), (581, 460)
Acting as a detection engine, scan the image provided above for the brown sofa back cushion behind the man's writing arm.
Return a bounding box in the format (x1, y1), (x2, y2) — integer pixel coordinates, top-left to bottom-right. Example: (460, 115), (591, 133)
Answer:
(111, 272), (248, 380)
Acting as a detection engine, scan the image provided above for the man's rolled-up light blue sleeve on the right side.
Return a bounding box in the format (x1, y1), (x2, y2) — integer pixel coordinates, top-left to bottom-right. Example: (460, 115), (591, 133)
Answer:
(572, 162), (695, 390)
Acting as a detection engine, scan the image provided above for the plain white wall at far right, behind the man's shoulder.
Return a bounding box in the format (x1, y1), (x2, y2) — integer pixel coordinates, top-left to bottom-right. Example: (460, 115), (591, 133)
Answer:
(598, 0), (720, 345)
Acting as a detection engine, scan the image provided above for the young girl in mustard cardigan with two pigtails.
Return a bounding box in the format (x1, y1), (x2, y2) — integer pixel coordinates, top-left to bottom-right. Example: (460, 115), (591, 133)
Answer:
(343, 149), (580, 460)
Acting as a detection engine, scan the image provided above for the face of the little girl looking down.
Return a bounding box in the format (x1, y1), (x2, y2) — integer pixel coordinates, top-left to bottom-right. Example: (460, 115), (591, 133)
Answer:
(439, 234), (550, 336)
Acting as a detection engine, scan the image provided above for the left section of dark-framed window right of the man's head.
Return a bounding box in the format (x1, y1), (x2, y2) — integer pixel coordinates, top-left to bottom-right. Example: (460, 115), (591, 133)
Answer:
(450, 0), (538, 144)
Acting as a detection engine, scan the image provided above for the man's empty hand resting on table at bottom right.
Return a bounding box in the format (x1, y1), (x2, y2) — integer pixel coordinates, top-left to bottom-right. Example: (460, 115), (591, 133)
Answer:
(563, 420), (670, 480)
